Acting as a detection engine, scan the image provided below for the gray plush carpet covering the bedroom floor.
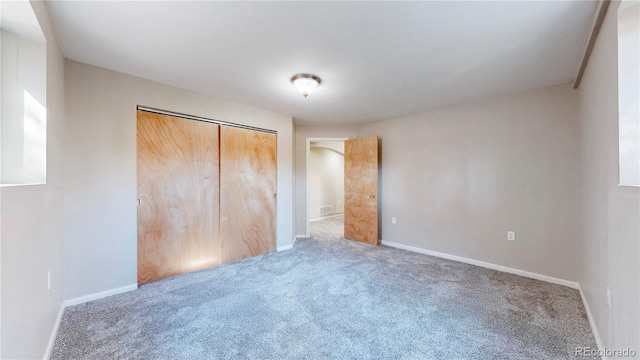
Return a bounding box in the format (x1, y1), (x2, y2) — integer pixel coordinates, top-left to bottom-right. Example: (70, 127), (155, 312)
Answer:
(51, 215), (596, 359)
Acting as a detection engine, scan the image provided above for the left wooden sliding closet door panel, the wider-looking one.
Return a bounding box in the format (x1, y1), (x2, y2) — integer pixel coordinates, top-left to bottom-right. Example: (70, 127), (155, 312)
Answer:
(137, 111), (220, 284)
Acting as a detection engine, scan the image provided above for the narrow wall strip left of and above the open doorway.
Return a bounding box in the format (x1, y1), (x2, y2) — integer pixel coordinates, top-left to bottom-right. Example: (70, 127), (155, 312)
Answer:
(294, 126), (357, 237)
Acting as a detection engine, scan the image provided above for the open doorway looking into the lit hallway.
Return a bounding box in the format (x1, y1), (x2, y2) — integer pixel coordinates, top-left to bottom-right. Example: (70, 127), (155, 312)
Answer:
(307, 139), (346, 239)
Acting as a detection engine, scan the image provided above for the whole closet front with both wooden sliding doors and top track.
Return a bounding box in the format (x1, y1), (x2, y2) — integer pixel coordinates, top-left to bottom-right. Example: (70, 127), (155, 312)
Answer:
(137, 108), (276, 285)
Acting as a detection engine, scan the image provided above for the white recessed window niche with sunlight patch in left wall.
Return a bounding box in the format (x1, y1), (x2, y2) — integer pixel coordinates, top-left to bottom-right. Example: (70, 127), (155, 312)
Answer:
(0, 1), (47, 186)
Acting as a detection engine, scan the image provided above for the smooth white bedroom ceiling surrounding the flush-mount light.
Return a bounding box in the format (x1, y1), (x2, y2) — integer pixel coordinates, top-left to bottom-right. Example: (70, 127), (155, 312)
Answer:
(49, 0), (596, 125)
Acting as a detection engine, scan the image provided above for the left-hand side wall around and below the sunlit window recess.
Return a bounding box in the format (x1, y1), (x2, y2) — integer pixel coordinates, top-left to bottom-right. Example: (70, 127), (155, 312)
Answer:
(0, 1), (65, 359)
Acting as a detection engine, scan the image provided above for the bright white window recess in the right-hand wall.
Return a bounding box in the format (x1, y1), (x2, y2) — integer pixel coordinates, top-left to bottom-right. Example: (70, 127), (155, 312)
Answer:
(618, 0), (640, 186)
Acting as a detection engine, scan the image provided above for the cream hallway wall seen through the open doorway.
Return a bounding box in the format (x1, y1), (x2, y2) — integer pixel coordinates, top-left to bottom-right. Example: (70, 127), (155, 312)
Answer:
(309, 147), (344, 219)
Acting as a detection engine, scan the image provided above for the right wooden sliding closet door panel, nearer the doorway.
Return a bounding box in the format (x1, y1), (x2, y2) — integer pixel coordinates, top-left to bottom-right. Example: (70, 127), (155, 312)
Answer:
(220, 126), (276, 263)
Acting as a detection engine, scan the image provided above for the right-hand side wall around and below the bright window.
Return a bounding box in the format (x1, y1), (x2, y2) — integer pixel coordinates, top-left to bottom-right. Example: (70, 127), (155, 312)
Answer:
(578, 2), (640, 352)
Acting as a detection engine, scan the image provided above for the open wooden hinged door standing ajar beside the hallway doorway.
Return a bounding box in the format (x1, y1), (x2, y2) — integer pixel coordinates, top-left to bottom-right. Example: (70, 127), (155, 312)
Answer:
(344, 136), (378, 245)
